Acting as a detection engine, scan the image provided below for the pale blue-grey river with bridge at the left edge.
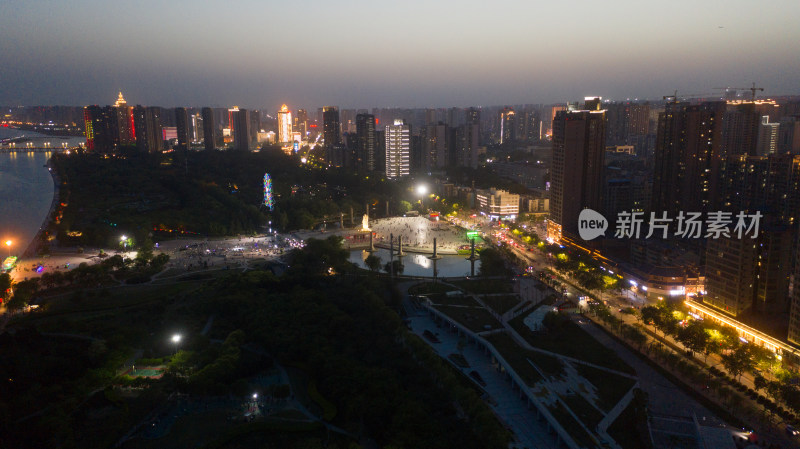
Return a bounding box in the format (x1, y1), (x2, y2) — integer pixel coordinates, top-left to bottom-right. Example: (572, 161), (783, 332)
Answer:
(0, 128), (74, 259)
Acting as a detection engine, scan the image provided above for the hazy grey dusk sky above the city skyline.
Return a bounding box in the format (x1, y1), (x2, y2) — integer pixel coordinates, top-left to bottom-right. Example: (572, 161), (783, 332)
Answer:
(0, 0), (800, 111)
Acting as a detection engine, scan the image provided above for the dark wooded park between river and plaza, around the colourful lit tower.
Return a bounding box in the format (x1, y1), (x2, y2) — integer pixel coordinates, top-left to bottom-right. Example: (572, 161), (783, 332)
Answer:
(51, 151), (402, 246)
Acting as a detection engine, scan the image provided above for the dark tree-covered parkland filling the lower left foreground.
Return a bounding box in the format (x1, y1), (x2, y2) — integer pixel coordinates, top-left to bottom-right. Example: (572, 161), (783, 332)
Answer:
(0, 237), (509, 449)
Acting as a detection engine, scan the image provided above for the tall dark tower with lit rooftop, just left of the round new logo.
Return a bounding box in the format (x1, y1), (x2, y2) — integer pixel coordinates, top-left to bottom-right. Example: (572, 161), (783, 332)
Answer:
(547, 98), (606, 242)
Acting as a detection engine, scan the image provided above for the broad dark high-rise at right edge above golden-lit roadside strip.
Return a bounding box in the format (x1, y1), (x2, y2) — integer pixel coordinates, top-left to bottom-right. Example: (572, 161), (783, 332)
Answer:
(704, 155), (800, 316)
